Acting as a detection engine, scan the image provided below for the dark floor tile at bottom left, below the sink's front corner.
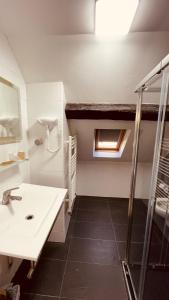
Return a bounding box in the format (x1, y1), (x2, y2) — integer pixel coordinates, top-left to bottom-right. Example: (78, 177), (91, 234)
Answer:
(24, 259), (65, 296)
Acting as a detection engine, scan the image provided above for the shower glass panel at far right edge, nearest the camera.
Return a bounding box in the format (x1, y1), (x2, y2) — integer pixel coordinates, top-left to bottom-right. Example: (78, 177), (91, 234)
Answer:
(143, 69), (169, 300)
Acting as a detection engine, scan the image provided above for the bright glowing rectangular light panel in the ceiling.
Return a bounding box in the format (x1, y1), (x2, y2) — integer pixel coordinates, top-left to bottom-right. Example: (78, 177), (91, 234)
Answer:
(95, 0), (139, 35)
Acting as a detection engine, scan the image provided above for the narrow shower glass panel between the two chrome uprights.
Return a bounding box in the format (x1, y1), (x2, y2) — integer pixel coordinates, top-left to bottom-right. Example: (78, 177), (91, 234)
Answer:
(128, 76), (161, 300)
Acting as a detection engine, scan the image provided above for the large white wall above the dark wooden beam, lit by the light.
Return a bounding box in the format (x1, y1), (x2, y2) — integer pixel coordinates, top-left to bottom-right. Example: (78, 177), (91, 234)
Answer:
(10, 32), (169, 103)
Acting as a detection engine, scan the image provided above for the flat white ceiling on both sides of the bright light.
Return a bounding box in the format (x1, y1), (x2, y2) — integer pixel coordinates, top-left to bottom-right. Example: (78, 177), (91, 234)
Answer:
(0, 0), (169, 36)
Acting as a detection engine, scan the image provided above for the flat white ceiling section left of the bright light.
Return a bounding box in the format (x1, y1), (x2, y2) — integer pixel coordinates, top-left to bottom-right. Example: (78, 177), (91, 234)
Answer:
(0, 0), (95, 36)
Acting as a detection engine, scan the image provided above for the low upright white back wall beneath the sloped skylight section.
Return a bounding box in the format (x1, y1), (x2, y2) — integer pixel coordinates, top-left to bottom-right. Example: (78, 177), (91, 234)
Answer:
(77, 161), (152, 199)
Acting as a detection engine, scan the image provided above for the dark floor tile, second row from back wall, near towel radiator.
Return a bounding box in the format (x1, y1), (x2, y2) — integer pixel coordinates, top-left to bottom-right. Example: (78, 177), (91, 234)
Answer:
(76, 209), (111, 223)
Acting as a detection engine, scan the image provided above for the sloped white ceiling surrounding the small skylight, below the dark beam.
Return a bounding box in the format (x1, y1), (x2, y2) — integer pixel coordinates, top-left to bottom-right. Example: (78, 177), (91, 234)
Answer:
(69, 120), (157, 163)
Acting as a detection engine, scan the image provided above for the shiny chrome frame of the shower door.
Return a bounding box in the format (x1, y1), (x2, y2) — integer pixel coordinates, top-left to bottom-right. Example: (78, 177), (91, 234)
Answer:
(122, 55), (169, 300)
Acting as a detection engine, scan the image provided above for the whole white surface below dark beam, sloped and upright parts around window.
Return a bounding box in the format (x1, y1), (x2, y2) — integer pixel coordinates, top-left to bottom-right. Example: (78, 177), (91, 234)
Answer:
(69, 120), (157, 199)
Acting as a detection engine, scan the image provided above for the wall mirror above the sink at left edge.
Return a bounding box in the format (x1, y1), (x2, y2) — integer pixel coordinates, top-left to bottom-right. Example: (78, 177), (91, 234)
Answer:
(0, 77), (22, 145)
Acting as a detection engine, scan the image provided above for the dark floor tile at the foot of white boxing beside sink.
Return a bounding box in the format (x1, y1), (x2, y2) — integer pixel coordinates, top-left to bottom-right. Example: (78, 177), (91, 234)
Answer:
(42, 242), (69, 260)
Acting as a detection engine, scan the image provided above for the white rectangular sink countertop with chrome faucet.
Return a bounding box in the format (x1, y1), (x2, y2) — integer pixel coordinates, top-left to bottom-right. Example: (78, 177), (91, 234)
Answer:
(0, 183), (67, 261)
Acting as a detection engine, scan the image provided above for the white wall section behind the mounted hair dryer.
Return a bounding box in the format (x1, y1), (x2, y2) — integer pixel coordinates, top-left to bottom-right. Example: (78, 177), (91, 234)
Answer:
(27, 82), (68, 187)
